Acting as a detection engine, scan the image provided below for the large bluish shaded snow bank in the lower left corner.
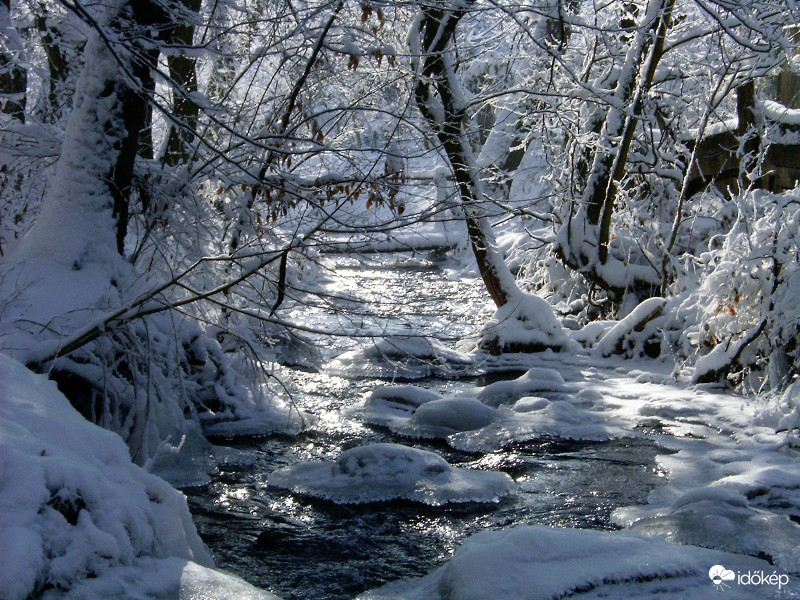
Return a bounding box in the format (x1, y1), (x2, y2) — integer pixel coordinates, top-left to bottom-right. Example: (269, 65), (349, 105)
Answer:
(0, 355), (213, 600)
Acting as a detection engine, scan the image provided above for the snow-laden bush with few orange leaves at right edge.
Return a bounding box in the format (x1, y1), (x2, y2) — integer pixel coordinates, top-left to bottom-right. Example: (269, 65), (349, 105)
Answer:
(676, 188), (800, 387)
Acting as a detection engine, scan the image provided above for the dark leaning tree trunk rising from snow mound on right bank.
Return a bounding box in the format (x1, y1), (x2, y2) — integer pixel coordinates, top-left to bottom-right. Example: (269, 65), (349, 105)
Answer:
(411, 2), (520, 307)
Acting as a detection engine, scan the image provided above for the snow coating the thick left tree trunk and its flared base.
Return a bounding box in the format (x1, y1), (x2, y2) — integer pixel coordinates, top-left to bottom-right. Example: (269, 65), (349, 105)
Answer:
(2, 21), (138, 362)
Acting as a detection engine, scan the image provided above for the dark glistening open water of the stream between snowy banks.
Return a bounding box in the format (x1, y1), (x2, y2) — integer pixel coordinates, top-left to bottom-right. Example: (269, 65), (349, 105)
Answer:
(185, 255), (663, 600)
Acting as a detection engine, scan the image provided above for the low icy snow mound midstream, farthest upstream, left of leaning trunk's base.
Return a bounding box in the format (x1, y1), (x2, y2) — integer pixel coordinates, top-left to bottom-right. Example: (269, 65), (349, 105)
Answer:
(326, 336), (474, 379)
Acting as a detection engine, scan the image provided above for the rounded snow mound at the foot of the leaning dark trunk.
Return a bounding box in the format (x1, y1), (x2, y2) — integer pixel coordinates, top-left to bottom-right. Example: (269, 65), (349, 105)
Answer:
(478, 293), (570, 354)
